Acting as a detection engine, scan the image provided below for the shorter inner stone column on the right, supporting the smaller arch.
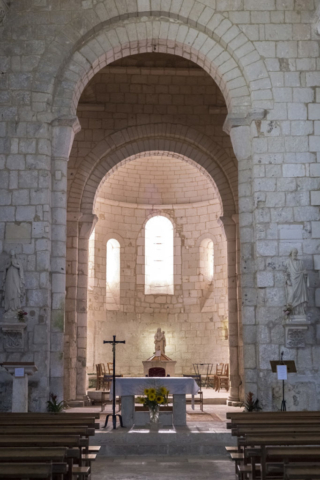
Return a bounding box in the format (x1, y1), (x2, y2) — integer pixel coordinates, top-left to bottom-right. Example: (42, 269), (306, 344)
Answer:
(220, 215), (241, 405)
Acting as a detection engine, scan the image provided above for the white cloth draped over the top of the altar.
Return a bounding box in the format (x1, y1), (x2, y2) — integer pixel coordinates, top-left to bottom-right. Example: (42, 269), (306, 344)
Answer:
(110, 377), (200, 400)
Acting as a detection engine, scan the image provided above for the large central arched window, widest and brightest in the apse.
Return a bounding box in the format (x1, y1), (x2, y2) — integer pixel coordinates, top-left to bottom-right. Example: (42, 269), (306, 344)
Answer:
(144, 215), (174, 295)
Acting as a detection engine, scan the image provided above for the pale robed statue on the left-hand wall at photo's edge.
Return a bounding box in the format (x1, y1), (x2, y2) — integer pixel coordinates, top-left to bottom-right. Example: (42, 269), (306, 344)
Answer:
(2, 250), (25, 312)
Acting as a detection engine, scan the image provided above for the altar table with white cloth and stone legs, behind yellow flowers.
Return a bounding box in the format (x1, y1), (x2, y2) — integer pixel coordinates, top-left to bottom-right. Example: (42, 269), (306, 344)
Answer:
(110, 377), (200, 428)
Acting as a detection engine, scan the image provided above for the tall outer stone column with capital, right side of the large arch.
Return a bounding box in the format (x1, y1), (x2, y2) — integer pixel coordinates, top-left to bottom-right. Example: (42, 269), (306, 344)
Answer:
(224, 108), (266, 394)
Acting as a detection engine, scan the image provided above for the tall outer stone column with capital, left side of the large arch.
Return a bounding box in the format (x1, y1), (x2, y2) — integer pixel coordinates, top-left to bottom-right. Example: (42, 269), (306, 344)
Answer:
(51, 117), (81, 399)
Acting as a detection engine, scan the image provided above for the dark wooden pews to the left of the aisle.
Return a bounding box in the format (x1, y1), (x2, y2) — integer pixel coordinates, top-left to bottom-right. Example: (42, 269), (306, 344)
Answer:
(0, 412), (100, 480)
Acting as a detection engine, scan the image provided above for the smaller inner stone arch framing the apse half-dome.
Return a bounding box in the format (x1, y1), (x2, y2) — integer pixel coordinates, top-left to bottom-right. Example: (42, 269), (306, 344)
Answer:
(68, 124), (238, 219)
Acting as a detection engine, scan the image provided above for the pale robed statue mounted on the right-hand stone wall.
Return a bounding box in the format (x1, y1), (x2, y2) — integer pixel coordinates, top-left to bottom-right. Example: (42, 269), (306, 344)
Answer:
(285, 248), (309, 315)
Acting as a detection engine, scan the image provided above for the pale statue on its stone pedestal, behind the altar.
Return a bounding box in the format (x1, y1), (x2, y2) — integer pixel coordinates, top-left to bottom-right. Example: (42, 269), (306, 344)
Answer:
(142, 328), (177, 377)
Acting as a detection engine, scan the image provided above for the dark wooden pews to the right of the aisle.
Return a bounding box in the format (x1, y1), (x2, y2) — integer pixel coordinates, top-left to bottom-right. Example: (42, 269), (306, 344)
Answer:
(226, 412), (320, 480)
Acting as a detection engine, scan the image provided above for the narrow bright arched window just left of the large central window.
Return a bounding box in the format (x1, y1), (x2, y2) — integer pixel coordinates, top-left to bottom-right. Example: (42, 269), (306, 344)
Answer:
(106, 238), (120, 310)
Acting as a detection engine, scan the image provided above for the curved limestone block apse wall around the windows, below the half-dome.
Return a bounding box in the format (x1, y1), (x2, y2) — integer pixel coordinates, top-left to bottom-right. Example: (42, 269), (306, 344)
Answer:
(87, 189), (229, 376)
